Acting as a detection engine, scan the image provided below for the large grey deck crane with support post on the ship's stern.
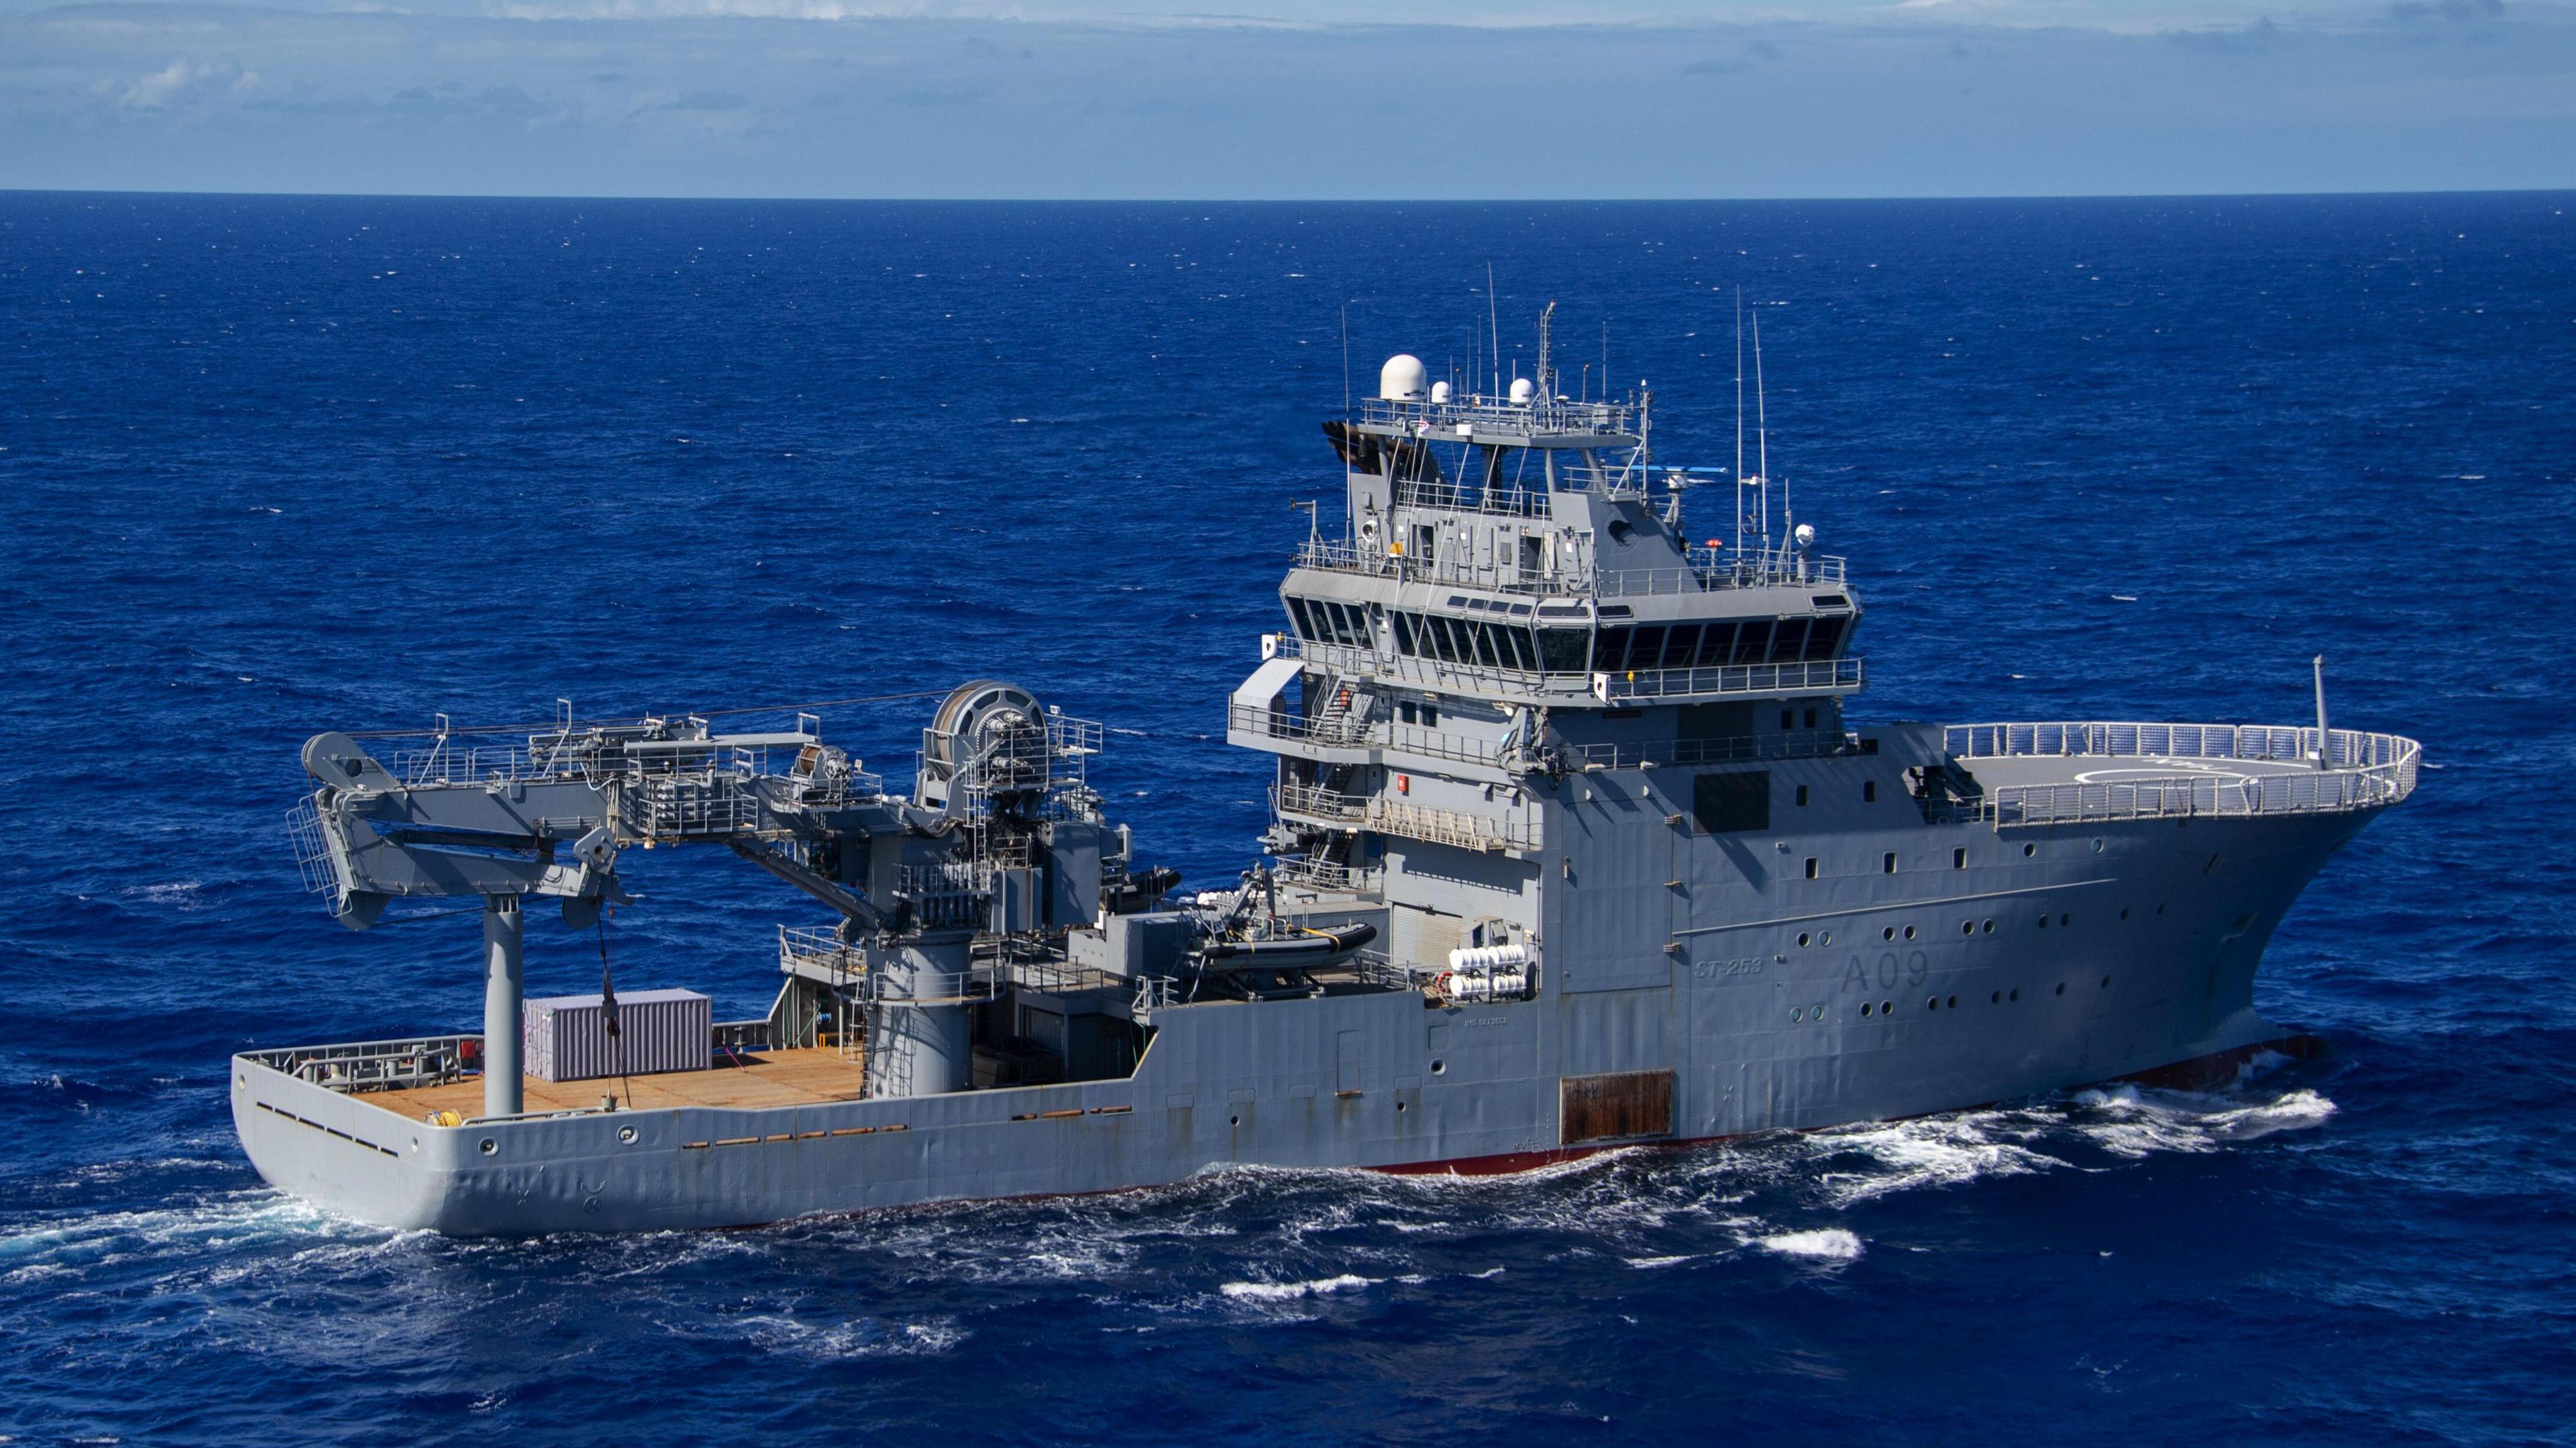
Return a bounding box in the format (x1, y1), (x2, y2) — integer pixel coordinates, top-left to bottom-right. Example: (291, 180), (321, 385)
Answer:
(294, 680), (1177, 1115)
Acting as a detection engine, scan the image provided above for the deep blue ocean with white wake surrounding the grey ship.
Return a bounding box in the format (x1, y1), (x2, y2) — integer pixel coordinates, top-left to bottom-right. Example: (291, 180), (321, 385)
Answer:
(0, 193), (2576, 1445)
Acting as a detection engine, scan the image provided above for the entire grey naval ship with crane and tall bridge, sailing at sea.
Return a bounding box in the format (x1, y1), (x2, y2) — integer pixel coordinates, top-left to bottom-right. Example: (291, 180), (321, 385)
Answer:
(229, 318), (2419, 1234)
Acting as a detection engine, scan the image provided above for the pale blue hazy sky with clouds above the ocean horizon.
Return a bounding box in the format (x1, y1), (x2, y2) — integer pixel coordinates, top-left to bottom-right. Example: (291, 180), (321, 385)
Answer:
(0, 0), (2576, 199)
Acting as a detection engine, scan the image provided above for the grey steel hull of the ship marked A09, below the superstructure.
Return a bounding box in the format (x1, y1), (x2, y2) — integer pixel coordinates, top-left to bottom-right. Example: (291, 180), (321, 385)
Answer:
(232, 798), (2375, 1234)
